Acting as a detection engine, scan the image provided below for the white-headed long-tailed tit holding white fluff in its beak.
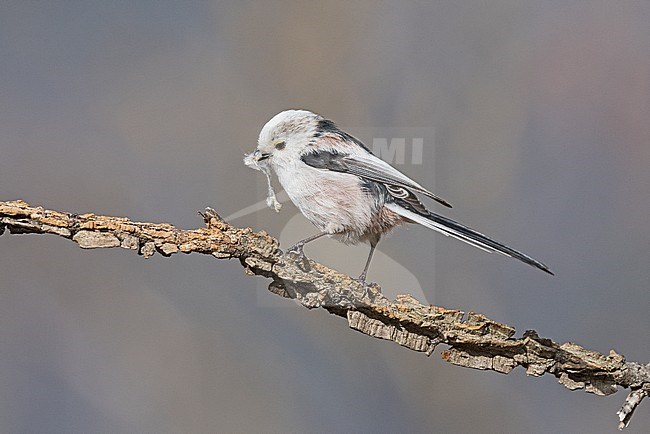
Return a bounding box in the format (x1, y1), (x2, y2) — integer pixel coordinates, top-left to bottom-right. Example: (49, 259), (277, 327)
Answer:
(244, 110), (553, 282)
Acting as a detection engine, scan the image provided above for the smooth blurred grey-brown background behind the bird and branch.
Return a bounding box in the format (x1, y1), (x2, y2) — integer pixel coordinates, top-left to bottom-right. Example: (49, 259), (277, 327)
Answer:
(0, 0), (650, 433)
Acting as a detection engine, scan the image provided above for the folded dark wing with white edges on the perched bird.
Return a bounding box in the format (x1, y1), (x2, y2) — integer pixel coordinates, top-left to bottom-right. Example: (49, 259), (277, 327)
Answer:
(301, 151), (451, 209)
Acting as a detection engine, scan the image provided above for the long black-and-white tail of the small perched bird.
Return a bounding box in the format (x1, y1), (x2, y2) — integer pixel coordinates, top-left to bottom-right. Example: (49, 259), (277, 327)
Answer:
(385, 203), (554, 275)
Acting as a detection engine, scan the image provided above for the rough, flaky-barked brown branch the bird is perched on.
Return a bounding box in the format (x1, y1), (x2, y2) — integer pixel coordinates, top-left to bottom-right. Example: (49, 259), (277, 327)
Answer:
(0, 201), (650, 429)
